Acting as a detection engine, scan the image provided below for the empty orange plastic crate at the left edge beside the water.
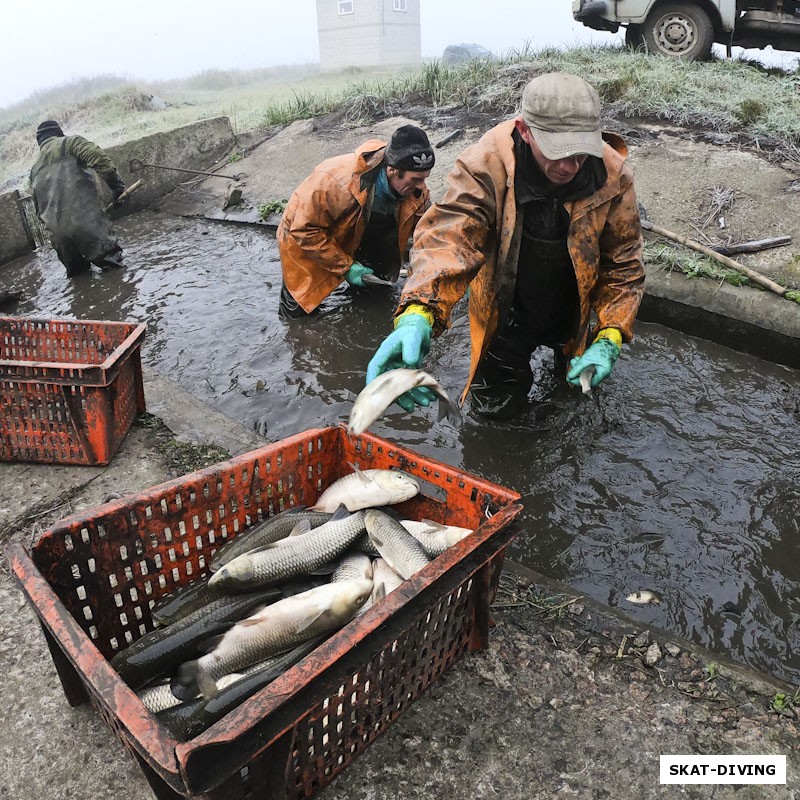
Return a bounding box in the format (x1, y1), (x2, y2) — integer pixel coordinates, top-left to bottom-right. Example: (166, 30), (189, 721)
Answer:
(0, 317), (145, 465)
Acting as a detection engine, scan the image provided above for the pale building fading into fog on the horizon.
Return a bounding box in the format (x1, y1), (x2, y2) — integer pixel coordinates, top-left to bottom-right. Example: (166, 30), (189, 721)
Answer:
(317, 0), (422, 70)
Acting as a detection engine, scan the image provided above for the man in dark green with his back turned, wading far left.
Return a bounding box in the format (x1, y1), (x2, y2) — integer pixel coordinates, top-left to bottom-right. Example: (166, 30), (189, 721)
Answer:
(30, 120), (130, 276)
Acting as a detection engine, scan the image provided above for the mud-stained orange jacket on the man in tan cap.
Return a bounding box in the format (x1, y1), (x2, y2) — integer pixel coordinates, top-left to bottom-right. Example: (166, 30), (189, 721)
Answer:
(396, 120), (644, 402)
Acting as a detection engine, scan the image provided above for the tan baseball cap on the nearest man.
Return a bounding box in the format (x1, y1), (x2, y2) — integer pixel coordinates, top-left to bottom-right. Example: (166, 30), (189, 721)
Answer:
(522, 72), (603, 161)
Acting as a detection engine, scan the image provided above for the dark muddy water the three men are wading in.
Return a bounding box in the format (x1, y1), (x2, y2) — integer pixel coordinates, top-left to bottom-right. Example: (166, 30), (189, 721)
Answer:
(2, 213), (800, 683)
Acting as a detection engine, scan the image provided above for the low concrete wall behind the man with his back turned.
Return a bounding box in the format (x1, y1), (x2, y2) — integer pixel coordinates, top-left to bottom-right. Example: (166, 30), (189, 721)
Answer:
(0, 117), (236, 264)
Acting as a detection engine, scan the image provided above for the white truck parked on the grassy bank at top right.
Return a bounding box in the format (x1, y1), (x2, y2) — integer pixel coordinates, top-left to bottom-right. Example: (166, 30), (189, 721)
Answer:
(572, 0), (800, 60)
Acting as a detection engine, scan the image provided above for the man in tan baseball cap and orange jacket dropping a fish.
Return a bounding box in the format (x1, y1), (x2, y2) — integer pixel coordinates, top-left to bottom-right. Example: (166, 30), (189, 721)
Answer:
(367, 72), (644, 419)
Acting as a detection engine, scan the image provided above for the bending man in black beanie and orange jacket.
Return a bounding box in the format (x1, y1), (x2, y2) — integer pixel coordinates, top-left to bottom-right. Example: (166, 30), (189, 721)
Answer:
(277, 125), (436, 318)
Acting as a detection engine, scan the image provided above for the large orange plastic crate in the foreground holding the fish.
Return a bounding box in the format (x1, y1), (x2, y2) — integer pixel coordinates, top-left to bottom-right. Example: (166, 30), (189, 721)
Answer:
(7, 427), (522, 800)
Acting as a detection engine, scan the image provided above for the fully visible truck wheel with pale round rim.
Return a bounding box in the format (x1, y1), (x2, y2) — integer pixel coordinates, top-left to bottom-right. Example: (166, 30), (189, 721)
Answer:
(642, 3), (714, 61)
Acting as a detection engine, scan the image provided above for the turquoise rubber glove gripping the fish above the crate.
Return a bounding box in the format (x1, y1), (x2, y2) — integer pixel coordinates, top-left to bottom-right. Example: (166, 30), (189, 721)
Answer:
(367, 305), (436, 412)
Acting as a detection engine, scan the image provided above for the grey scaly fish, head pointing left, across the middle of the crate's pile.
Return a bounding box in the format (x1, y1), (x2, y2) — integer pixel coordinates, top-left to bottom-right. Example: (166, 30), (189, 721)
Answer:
(208, 508), (364, 592)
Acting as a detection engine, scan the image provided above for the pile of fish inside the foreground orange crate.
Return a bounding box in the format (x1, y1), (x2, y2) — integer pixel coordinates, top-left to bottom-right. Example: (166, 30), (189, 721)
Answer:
(111, 467), (472, 741)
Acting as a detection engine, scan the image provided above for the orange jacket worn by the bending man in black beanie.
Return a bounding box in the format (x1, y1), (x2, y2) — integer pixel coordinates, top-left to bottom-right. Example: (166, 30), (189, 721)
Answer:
(277, 139), (430, 313)
